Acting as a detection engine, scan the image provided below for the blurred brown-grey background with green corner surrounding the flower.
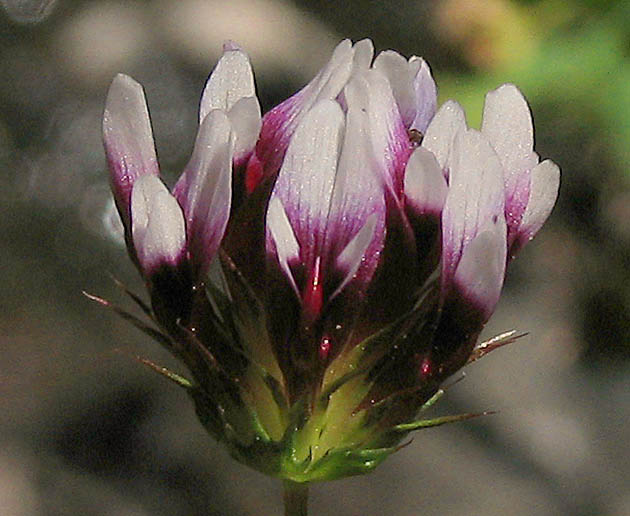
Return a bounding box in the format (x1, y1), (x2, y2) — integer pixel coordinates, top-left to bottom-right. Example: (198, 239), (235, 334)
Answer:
(0, 0), (630, 516)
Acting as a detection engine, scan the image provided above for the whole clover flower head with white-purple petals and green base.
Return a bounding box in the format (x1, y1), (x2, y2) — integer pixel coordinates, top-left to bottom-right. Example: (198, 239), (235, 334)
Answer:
(103, 40), (559, 481)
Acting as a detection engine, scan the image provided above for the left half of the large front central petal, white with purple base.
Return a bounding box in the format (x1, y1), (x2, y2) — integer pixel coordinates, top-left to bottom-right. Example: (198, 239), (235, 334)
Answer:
(268, 100), (344, 280)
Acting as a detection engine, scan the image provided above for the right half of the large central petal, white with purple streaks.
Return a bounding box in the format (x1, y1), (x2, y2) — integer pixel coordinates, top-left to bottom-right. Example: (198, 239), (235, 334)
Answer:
(325, 70), (413, 306)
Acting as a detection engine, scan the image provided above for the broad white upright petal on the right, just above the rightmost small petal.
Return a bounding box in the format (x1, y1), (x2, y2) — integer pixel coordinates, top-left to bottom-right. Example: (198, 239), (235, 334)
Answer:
(481, 84), (538, 195)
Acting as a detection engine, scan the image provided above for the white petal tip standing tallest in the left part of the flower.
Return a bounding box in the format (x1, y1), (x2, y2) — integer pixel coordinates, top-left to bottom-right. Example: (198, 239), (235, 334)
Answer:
(199, 47), (256, 123)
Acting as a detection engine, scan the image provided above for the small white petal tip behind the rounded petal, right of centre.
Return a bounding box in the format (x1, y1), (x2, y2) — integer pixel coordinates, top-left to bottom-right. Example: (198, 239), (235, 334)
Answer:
(422, 100), (468, 179)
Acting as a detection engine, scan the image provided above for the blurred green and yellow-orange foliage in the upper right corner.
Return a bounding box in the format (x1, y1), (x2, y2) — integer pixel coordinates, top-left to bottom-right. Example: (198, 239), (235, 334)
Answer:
(438, 0), (630, 174)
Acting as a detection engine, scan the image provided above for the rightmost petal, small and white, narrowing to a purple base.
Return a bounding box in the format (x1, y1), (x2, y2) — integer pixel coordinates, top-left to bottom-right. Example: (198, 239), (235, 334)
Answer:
(509, 159), (560, 253)
